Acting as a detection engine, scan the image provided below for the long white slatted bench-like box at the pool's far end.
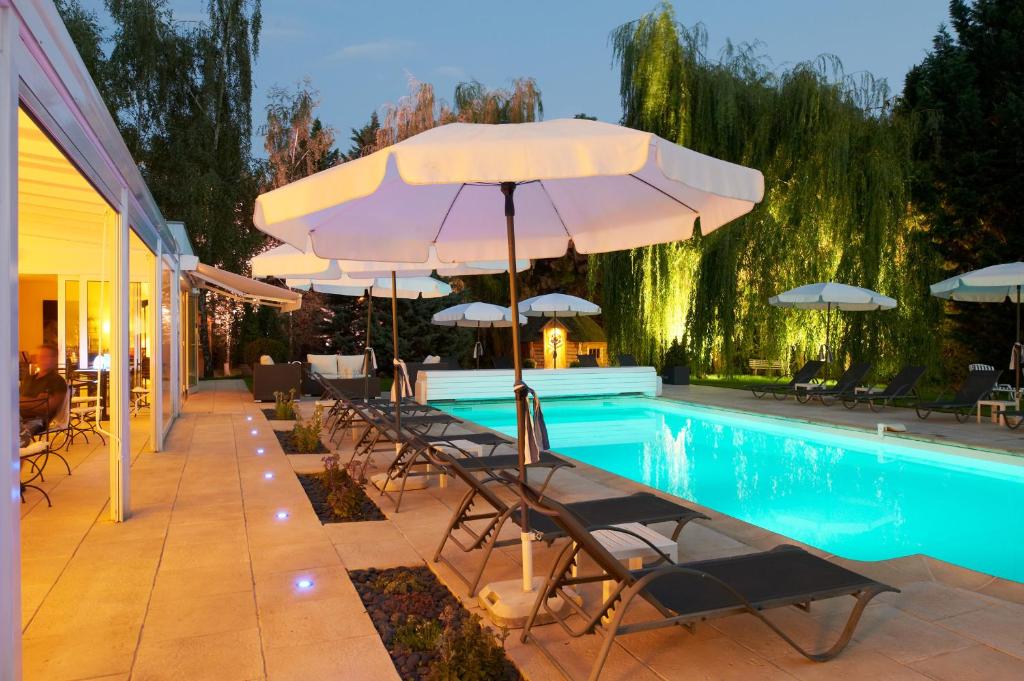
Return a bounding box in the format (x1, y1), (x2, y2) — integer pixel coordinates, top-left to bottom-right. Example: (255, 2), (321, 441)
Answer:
(416, 367), (662, 403)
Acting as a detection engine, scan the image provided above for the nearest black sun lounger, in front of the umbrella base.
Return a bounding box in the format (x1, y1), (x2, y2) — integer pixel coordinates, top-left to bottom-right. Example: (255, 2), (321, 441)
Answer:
(521, 487), (898, 681)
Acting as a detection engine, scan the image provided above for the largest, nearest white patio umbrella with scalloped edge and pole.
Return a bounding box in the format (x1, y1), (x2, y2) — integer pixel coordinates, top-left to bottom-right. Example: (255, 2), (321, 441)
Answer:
(253, 119), (764, 614)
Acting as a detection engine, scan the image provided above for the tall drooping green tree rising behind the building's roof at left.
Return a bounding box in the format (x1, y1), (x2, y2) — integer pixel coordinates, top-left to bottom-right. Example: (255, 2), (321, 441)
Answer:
(58, 0), (263, 372)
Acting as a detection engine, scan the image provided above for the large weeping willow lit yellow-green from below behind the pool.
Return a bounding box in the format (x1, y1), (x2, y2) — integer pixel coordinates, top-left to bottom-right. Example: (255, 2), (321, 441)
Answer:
(590, 5), (939, 374)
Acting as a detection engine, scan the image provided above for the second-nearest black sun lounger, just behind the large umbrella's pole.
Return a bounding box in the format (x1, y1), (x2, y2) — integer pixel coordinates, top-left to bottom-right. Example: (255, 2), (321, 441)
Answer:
(434, 454), (709, 596)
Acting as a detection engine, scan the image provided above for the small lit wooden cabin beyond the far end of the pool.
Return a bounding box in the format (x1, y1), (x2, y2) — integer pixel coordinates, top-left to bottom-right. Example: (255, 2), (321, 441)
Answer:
(521, 316), (610, 369)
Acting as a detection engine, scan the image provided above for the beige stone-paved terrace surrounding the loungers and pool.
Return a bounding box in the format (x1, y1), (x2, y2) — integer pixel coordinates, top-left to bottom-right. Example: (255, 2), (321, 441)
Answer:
(23, 381), (1024, 681)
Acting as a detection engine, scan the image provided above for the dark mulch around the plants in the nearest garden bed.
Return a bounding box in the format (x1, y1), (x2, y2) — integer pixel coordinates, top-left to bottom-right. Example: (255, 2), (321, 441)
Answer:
(348, 565), (522, 681)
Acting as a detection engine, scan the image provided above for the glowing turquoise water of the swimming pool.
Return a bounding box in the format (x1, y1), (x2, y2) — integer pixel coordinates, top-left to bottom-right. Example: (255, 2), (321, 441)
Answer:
(437, 397), (1024, 582)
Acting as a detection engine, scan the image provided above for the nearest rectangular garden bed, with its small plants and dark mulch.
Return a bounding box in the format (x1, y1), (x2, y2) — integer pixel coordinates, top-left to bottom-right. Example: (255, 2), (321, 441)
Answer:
(349, 566), (522, 681)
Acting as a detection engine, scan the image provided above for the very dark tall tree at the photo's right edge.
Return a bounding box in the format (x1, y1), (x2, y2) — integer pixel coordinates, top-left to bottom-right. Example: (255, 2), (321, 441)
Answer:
(900, 0), (1024, 366)
